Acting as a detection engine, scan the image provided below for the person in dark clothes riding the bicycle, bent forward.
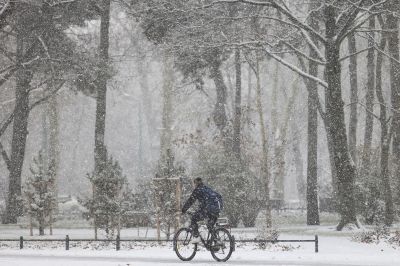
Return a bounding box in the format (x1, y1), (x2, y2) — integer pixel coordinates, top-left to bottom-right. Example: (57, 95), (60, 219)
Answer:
(182, 177), (223, 244)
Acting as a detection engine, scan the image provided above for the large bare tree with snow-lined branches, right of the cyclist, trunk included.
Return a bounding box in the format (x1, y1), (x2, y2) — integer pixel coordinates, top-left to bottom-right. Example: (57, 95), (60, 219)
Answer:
(213, 0), (383, 230)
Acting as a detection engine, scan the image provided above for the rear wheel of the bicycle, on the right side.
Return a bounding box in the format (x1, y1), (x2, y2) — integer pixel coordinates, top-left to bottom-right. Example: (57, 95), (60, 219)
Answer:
(210, 228), (235, 261)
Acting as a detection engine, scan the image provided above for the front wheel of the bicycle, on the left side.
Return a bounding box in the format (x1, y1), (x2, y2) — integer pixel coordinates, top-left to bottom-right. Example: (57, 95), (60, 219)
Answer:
(173, 228), (197, 261)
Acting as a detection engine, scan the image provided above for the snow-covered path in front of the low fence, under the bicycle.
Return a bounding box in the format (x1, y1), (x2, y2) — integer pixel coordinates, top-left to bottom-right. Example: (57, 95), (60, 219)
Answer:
(0, 237), (400, 266)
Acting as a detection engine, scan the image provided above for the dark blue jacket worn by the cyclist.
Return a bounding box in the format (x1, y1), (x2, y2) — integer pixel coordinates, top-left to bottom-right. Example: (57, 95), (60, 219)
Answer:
(182, 185), (223, 214)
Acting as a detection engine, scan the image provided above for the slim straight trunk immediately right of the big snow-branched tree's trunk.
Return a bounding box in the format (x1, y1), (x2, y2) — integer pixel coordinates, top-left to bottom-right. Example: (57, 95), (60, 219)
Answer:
(347, 34), (358, 162)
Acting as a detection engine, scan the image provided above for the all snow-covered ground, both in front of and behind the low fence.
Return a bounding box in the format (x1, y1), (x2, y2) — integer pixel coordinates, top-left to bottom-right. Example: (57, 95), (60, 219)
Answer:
(0, 226), (400, 266)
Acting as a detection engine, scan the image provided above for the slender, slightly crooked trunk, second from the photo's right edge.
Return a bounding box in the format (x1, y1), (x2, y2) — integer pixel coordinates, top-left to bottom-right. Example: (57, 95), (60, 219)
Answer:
(375, 32), (394, 226)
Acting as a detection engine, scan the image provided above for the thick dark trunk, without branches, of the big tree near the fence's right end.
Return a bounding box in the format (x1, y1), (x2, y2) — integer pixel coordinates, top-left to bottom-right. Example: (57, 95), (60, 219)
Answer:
(325, 5), (359, 231)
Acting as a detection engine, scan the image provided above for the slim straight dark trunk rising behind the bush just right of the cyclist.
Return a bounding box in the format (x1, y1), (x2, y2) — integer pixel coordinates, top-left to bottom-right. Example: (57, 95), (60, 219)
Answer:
(232, 49), (242, 160)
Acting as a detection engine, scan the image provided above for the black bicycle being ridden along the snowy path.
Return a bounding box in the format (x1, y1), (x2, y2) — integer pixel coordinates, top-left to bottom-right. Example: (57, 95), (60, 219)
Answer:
(173, 213), (235, 261)
